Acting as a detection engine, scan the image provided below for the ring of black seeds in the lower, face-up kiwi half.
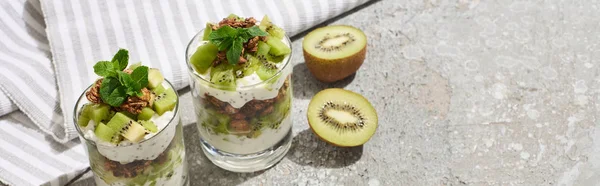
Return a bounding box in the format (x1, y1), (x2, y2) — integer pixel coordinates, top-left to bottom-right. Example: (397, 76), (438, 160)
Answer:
(319, 101), (365, 131)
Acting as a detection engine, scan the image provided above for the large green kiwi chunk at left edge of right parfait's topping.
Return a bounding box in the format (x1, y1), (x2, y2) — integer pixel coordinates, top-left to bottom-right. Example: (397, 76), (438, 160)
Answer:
(190, 42), (219, 74)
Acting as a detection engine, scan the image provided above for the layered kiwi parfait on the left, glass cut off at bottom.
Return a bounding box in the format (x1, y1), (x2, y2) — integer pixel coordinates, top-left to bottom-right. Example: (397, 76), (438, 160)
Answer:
(73, 49), (189, 185)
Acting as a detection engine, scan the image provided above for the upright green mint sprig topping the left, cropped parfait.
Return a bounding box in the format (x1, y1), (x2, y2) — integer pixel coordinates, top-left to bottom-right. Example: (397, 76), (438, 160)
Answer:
(94, 49), (148, 107)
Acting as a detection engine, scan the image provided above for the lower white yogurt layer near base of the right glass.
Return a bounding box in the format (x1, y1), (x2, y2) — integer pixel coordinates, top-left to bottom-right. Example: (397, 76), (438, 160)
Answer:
(199, 114), (292, 154)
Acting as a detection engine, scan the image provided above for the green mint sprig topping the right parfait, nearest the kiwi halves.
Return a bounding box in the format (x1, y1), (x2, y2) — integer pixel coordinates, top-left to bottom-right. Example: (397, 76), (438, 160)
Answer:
(208, 25), (268, 65)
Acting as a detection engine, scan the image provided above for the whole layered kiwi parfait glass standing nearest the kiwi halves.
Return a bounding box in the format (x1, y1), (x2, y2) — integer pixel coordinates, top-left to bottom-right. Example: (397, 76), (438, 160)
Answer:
(186, 15), (292, 172)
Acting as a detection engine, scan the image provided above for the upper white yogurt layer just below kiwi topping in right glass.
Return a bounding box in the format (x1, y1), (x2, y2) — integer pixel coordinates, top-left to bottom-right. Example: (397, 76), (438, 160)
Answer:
(192, 39), (292, 108)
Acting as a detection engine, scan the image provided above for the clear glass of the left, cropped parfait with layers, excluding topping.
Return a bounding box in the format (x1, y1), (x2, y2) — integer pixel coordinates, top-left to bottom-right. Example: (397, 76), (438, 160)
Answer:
(73, 80), (189, 186)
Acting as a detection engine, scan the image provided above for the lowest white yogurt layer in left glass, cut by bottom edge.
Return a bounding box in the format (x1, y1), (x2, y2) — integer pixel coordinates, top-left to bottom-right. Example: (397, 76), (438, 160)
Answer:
(94, 158), (187, 186)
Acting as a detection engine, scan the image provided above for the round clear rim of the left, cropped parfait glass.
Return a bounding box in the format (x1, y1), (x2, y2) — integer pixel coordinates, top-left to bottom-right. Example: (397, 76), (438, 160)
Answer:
(73, 79), (179, 147)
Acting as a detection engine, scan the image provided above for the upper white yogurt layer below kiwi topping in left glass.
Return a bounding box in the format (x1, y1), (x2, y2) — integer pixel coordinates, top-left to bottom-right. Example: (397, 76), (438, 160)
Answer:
(81, 82), (179, 164)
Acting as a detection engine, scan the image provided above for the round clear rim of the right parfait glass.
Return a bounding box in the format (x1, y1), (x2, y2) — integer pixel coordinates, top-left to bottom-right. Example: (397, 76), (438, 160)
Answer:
(185, 28), (294, 91)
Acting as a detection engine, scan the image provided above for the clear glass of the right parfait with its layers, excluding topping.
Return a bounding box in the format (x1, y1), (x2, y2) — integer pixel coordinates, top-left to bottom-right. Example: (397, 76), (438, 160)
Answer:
(186, 30), (292, 172)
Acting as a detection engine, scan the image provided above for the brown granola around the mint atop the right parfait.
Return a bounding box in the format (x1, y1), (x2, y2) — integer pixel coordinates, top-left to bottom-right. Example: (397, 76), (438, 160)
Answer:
(212, 17), (267, 66)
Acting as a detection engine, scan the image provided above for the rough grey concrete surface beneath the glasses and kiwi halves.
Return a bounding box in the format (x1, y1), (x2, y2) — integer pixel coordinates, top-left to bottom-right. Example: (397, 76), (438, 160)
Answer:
(76, 0), (600, 186)
